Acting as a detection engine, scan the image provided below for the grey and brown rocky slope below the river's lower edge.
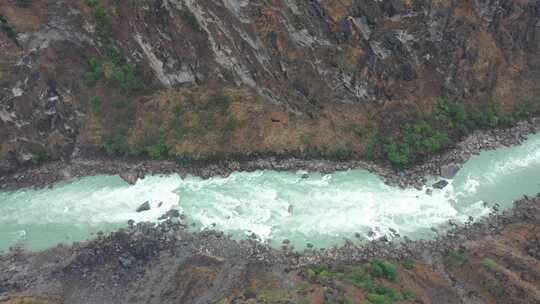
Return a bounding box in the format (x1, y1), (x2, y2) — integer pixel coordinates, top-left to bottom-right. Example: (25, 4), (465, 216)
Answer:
(0, 195), (540, 304)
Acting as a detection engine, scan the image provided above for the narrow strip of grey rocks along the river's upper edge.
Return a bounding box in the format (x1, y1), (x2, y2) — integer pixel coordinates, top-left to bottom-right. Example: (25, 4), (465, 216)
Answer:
(0, 118), (540, 190)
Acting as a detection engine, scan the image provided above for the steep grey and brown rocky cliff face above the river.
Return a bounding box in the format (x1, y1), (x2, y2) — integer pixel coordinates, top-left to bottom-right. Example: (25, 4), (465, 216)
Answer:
(0, 0), (540, 172)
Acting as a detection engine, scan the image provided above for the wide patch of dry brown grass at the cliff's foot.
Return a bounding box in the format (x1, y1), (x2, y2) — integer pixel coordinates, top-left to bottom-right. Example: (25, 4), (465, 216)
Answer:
(129, 88), (367, 157)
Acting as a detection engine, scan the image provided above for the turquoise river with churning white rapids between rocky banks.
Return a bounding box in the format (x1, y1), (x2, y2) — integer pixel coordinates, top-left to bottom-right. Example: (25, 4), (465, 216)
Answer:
(0, 134), (540, 251)
